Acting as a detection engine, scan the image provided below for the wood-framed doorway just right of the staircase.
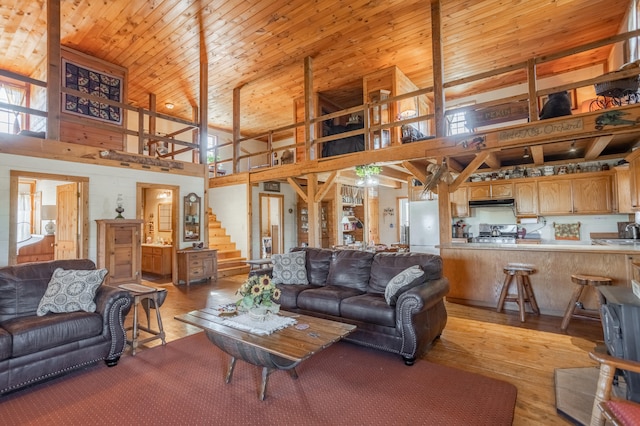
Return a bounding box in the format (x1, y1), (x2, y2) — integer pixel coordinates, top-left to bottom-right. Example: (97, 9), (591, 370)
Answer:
(260, 193), (284, 258)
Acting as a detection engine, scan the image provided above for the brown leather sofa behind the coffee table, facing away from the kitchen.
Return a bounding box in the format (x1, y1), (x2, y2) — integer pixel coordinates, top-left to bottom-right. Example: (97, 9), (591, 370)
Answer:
(272, 248), (449, 365)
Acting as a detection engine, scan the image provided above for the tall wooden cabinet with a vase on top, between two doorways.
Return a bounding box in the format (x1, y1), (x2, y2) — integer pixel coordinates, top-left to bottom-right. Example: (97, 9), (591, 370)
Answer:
(96, 219), (143, 285)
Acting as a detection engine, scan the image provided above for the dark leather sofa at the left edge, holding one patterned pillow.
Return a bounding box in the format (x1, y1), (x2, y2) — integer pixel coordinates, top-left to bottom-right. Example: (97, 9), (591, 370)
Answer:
(0, 259), (131, 394)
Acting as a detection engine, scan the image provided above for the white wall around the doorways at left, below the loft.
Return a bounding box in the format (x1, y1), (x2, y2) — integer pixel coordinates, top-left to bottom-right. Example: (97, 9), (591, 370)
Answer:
(0, 153), (205, 266)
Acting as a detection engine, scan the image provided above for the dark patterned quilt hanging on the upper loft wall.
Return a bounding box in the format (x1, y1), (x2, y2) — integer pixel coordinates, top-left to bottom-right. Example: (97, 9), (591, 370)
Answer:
(62, 59), (123, 124)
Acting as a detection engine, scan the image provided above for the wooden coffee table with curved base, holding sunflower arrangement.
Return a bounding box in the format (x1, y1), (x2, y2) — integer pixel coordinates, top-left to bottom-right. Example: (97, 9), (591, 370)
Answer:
(175, 308), (356, 400)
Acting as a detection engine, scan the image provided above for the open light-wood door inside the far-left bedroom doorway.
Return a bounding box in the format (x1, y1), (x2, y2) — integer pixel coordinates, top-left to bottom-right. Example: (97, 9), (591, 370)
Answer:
(55, 182), (79, 259)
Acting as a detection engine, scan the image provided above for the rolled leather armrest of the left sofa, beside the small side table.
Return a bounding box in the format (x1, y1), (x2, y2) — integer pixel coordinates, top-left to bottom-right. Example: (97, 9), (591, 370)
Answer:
(95, 285), (132, 360)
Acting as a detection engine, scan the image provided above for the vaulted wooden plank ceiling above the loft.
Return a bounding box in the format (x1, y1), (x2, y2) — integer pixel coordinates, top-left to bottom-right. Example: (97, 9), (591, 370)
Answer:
(0, 0), (630, 139)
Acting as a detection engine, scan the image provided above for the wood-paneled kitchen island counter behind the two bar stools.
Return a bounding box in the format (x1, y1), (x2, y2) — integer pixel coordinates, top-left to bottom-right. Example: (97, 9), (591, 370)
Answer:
(440, 243), (640, 317)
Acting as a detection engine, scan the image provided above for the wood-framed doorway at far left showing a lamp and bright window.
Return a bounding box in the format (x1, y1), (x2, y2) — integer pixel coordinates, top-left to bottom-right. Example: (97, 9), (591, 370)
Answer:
(8, 170), (89, 265)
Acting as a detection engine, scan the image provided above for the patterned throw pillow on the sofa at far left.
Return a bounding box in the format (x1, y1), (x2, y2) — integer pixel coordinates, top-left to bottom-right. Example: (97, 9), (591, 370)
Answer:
(36, 268), (107, 316)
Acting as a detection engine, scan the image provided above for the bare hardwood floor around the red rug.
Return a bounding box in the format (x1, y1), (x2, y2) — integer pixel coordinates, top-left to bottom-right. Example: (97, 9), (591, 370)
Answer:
(132, 275), (603, 425)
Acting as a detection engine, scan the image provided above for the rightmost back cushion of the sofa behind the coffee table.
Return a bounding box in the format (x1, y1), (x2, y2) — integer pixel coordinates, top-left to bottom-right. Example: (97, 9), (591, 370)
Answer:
(367, 253), (442, 294)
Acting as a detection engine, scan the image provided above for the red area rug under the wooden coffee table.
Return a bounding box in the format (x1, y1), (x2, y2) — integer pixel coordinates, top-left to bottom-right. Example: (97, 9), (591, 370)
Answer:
(0, 333), (516, 426)
